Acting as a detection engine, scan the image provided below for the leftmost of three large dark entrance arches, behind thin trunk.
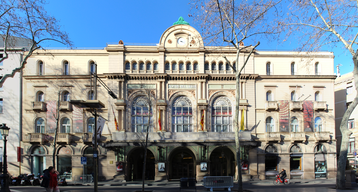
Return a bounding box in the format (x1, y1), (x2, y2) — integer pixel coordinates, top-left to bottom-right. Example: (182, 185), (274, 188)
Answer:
(126, 148), (155, 181)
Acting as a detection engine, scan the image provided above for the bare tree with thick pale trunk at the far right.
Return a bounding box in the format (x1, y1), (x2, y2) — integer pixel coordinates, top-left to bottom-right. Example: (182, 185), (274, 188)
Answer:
(280, 0), (358, 189)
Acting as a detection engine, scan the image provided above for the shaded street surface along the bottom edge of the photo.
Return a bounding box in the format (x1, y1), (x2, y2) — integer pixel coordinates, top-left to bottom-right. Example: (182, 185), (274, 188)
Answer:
(7, 182), (358, 192)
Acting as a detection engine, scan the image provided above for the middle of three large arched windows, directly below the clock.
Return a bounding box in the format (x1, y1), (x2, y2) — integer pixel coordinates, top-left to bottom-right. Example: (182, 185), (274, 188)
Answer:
(172, 96), (193, 132)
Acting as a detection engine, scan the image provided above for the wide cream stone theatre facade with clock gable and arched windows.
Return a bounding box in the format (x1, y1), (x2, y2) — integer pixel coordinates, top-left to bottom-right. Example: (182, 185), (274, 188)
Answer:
(22, 19), (336, 181)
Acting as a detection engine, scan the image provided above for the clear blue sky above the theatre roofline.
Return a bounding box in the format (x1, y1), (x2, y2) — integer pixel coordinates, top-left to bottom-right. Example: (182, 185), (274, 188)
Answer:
(46, 0), (353, 74)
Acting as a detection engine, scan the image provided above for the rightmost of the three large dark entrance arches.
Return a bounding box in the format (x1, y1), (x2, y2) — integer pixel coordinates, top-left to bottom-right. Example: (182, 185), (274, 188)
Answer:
(209, 147), (235, 176)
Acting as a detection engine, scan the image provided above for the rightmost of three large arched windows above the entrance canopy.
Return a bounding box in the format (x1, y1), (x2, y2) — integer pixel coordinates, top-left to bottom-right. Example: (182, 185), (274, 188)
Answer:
(212, 97), (232, 132)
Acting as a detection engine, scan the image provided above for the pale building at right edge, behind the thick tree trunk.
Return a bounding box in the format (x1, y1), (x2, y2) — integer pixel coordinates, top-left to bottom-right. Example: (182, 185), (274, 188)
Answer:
(335, 72), (358, 168)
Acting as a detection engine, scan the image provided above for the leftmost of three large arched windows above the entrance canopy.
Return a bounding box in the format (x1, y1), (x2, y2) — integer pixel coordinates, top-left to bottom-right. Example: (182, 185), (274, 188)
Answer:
(132, 96), (153, 132)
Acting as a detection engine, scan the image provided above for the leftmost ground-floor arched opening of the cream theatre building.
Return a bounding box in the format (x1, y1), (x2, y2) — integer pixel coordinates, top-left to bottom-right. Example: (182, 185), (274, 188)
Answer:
(31, 146), (46, 175)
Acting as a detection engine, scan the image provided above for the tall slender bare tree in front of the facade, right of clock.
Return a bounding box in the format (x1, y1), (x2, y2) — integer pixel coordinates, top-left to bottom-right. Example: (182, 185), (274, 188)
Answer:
(193, 0), (280, 191)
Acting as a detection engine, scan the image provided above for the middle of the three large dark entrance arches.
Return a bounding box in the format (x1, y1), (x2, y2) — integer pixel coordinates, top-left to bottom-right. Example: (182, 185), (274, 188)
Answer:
(169, 148), (195, 179)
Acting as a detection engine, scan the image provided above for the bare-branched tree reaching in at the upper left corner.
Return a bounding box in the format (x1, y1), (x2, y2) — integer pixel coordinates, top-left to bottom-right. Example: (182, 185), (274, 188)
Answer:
(0, 0), (72, 87)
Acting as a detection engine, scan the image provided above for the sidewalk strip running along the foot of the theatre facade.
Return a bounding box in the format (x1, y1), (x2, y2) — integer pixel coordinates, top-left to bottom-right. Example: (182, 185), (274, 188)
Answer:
(68, 179), (358, 187)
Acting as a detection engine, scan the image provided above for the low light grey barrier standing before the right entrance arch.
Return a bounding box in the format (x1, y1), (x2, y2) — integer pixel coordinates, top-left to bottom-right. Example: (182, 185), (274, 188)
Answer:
(203, 176), (234, 191)
